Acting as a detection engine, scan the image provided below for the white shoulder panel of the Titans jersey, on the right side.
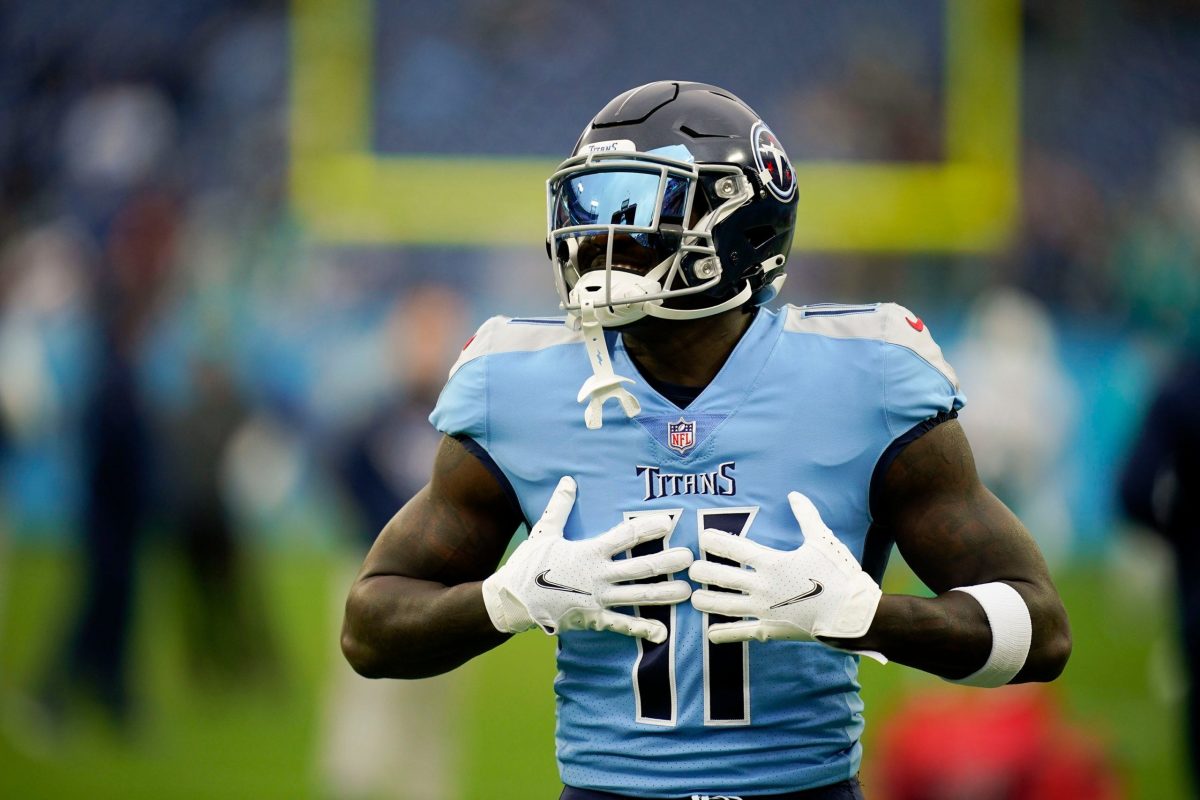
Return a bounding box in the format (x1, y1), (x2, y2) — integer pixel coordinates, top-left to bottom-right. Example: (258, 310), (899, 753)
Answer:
(784, 302), (959, 390)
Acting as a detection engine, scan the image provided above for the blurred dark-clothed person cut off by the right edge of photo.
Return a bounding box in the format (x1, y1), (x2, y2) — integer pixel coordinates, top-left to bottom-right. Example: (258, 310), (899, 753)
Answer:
(1120, 341), (1200, 786)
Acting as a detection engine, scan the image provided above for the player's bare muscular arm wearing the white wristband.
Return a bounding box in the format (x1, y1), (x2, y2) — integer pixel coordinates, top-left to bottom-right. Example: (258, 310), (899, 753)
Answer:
(838, 421), (1070, 684)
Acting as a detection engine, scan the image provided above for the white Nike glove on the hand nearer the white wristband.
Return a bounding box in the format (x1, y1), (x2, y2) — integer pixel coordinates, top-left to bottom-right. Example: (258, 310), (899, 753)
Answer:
(688, 492), (883, 658)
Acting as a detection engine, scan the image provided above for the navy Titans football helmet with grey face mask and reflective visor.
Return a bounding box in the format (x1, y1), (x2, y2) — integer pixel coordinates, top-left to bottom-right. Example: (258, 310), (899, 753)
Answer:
(546, 80), (797, 326)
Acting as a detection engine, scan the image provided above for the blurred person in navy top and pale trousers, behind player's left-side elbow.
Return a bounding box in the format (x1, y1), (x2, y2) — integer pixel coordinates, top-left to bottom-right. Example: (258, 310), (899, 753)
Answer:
(320, 284), (467, 800)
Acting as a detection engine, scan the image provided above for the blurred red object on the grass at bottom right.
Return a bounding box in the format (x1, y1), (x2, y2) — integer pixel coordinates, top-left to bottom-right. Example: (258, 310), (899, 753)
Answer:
(866, 687), (1124, 800)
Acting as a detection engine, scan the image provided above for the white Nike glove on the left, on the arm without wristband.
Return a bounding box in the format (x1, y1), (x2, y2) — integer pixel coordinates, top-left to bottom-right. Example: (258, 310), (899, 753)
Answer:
(484, 477), (692, 642)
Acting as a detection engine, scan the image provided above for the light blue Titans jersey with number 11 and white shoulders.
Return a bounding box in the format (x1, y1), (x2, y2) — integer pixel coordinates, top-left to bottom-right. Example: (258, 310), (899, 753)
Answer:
(431, 303), (964, 798)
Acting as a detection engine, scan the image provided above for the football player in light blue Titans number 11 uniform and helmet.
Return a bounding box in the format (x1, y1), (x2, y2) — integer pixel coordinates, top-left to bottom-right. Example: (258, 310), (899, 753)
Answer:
(342, 82), (1070, 800)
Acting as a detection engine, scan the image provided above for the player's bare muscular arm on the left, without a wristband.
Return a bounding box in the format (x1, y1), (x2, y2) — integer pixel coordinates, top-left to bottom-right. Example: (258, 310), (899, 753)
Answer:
(342, 437), (521, 678)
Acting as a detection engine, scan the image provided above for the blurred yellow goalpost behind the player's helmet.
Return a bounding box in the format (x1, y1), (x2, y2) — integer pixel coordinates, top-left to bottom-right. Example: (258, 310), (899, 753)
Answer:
(289, 0), (1020, 252)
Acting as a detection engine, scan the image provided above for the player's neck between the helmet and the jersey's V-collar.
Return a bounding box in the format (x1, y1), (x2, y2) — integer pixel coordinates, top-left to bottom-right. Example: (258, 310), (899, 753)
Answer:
(622, 309), (755, 386)
